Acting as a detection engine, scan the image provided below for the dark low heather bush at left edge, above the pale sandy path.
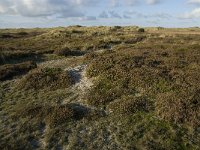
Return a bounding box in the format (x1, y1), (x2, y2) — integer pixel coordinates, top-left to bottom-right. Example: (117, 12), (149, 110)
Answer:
(0, 61), (37, 81)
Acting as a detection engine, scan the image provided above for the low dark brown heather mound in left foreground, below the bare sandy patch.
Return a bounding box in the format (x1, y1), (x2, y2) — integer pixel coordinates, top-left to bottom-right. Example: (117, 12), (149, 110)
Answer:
(17, 104), (86, 127)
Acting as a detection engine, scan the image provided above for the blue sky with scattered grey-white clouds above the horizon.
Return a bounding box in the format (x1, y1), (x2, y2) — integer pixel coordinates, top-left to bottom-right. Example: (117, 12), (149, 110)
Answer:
(0, 0), (200, 28)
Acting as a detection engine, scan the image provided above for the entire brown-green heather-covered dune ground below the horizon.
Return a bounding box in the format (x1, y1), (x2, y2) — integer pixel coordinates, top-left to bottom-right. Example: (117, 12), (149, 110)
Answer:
(0, 26), (200, 150)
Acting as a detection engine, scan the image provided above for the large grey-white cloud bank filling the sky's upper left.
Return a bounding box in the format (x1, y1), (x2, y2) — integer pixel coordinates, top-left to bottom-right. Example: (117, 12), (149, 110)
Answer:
(0, 0), (98, 17)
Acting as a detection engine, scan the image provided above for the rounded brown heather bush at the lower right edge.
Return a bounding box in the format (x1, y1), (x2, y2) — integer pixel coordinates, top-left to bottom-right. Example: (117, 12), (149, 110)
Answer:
(156, 90), (200, 127)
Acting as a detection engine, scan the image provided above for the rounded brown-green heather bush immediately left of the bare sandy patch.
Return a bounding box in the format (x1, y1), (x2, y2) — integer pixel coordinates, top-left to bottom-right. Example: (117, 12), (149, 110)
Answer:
(19, 68), (75, 90)
